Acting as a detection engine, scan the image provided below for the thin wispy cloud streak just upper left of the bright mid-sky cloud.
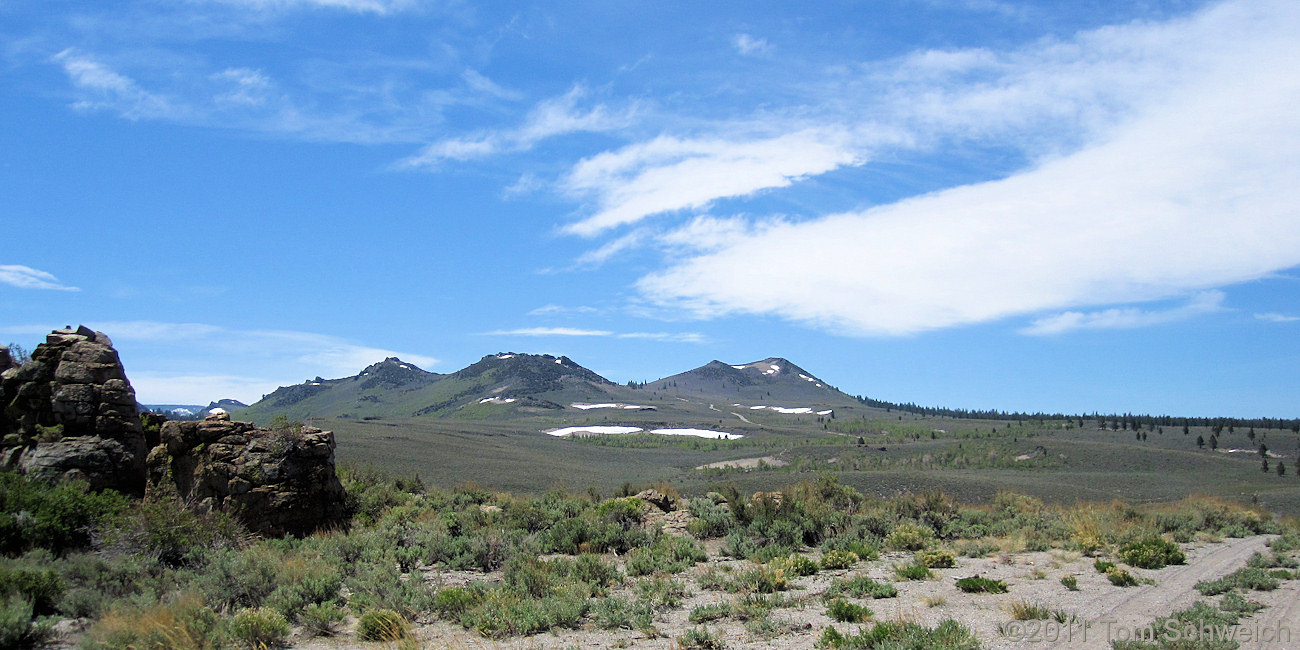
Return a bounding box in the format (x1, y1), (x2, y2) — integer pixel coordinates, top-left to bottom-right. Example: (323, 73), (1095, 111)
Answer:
(397, 86), (636, 168)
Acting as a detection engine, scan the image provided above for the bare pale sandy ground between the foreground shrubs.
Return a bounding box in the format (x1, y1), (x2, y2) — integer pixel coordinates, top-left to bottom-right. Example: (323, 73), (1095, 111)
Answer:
(293, 536), (1300, 650)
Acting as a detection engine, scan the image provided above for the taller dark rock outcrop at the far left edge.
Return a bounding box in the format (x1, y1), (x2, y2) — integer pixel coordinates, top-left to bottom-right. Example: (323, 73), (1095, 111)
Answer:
(0, 326), (146, 494)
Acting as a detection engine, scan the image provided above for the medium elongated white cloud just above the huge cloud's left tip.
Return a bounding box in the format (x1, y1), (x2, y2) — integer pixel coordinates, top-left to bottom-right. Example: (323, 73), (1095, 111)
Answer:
(563, 129), (862, 237)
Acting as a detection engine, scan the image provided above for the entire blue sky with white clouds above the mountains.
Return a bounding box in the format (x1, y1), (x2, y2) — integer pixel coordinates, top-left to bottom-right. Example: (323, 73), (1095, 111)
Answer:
(0, 0), (1300, 417)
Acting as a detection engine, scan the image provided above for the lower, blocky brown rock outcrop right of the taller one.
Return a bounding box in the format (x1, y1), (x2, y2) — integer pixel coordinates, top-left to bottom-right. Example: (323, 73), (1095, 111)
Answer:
(148, 412), (346, 536)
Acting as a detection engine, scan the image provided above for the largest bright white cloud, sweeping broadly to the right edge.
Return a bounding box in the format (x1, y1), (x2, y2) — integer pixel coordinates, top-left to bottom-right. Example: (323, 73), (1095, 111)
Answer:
(621, 1), (1300, 335)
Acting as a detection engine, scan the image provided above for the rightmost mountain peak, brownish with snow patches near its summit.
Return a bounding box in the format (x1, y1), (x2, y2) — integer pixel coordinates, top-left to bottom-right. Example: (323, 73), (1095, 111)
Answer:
(646, 356), (858, 408)
